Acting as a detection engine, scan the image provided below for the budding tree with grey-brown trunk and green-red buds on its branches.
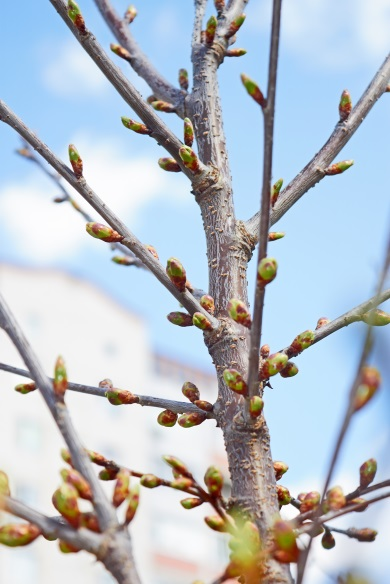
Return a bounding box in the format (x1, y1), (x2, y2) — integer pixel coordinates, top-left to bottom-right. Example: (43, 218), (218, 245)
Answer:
(0, 0), (390, 584)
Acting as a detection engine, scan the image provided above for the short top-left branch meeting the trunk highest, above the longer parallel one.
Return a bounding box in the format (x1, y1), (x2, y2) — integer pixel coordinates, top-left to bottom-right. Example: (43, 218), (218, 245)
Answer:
(95, 0), (186, 118)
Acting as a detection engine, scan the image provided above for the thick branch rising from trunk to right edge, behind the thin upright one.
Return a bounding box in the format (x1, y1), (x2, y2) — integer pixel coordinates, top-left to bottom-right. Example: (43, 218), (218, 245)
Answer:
(245, 55), (390, 239)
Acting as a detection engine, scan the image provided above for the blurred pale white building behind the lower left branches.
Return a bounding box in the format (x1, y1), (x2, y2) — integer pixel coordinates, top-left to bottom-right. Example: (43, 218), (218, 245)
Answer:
(0, 265), (226, 584)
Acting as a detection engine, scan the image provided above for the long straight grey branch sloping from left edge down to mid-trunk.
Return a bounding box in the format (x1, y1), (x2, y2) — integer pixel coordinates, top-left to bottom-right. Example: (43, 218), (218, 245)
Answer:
(0, 100), (219, 329)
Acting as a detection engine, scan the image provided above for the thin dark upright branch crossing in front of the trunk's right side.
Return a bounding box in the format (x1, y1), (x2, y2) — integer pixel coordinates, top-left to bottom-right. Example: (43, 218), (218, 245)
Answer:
(248, 0), (282, 398)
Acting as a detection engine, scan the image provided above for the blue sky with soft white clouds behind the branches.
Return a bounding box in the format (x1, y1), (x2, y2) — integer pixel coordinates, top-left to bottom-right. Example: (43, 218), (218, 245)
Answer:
(0, 0), (390, 582)
